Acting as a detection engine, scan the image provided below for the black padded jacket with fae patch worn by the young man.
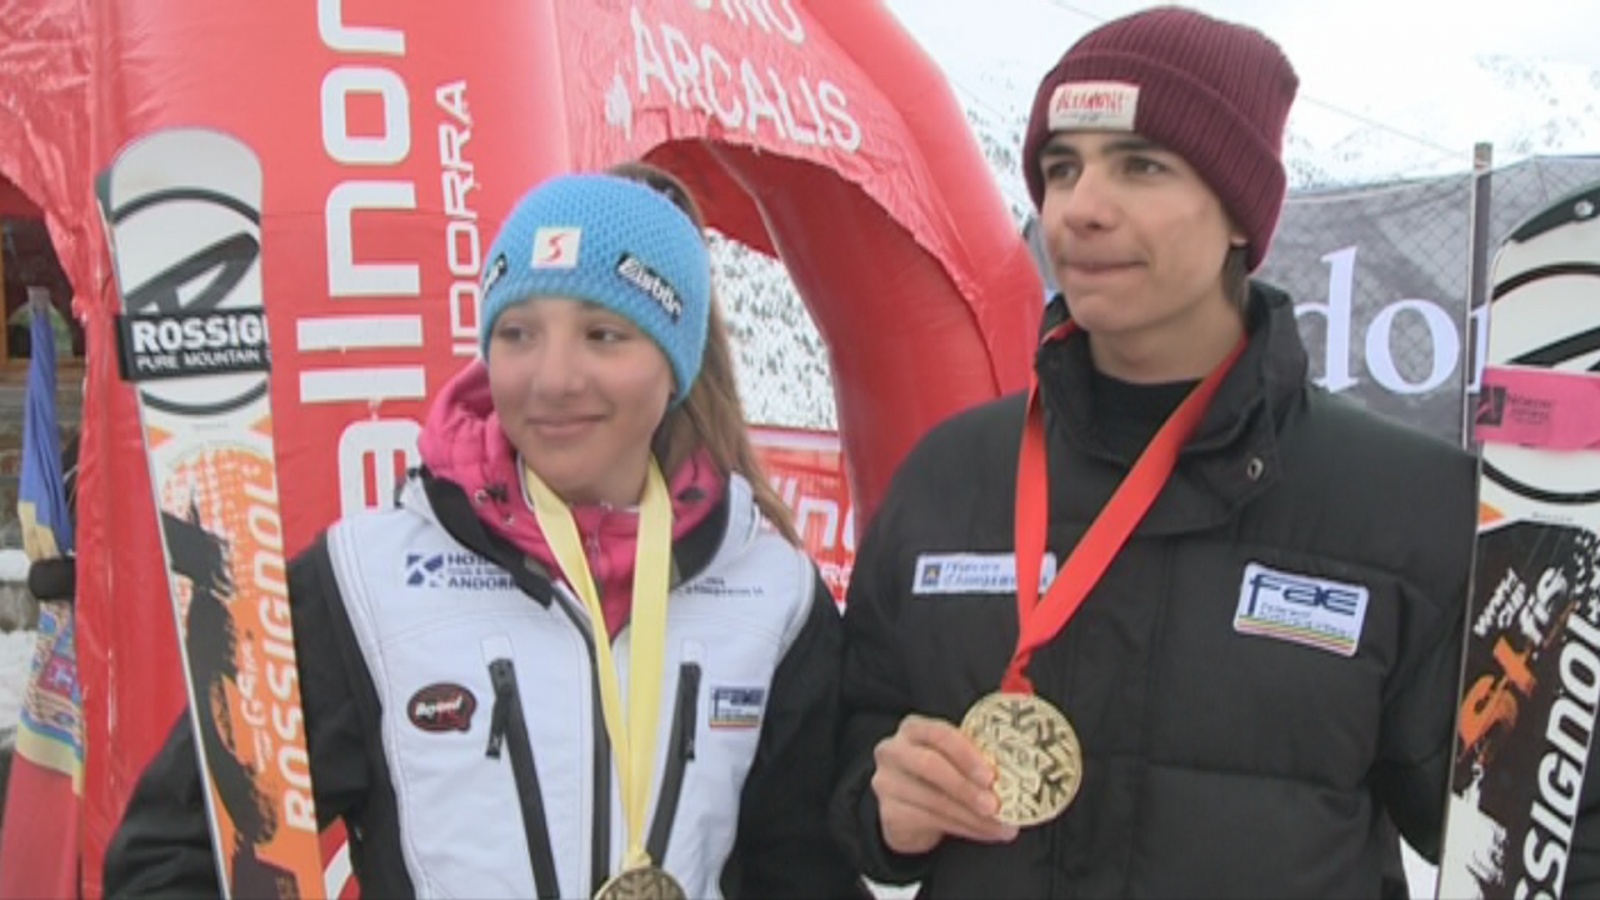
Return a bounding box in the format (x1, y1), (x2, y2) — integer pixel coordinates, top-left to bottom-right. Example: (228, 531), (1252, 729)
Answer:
(834, 285), (1475, 897)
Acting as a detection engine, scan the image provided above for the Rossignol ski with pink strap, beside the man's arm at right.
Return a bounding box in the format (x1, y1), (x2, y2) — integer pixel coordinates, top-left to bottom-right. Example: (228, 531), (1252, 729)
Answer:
(1438, 184), (1600, 898)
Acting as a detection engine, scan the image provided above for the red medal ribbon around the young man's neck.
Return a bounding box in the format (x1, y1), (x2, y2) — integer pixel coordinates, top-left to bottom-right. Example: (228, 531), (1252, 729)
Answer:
(1000, 323), (1248, 693)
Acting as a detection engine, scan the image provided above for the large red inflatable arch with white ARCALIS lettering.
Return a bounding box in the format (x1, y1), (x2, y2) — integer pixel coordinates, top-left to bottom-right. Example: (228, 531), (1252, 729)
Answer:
(0, 0), (1042, 897)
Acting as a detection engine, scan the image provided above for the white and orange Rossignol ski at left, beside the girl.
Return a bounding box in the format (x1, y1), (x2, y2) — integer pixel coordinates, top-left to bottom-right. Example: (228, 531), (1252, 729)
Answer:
(98, 128), (325, 897)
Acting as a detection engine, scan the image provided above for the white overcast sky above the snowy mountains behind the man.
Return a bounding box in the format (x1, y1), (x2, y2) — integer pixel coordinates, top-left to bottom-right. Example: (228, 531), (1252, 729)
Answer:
(888, 0), (1600, 176)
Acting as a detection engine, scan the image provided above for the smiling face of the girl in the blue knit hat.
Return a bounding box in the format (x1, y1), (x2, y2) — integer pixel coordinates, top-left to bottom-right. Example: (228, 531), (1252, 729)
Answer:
(488, 298), (674, 506)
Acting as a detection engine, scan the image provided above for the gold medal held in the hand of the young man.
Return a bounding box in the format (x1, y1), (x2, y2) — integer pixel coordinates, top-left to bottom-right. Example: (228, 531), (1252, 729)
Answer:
(962, 692), (1083, 828)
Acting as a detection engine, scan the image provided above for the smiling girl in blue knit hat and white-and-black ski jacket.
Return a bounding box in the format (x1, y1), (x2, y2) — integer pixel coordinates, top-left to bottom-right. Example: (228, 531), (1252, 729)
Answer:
(106, 165), (858, 897)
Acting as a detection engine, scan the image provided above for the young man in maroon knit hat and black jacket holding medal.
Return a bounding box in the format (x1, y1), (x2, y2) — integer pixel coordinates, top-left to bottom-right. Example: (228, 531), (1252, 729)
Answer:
(835, 8), (1475, 897)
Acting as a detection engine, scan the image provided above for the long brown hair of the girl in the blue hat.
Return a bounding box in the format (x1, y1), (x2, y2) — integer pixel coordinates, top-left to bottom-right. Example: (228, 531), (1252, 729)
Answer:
(608, 162), (802, 546)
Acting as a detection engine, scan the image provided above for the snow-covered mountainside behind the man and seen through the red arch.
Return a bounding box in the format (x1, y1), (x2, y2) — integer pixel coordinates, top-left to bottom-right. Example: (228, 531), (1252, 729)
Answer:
(726, 50), (1600, 429)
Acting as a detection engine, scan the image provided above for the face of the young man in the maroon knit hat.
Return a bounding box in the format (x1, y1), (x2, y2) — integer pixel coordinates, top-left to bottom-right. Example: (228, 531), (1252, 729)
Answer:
(1038, 131), (1243, 340)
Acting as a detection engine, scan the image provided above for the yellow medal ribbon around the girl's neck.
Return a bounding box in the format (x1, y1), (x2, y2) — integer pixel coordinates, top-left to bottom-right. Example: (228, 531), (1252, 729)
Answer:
(523, 458), (672, 870)
